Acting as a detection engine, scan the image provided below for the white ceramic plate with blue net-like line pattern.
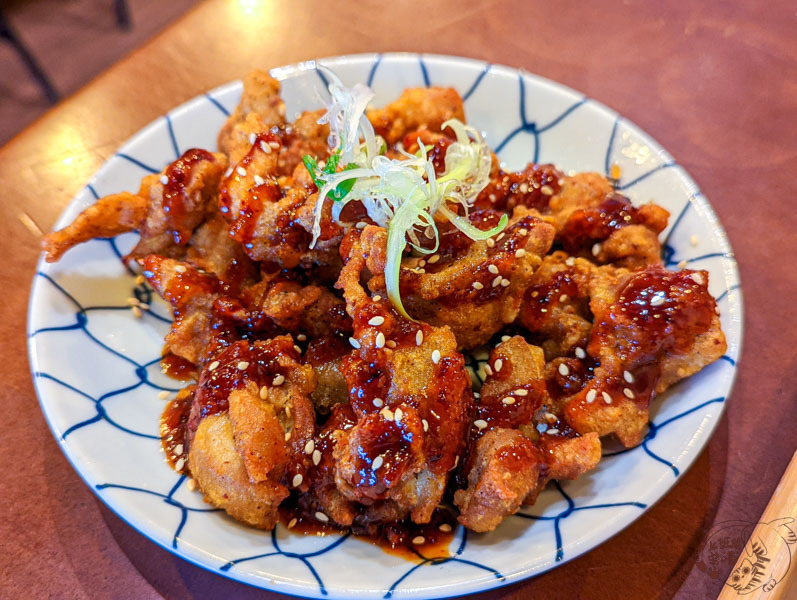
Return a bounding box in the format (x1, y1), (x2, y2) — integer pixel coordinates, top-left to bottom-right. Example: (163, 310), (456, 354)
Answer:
(28, 54), (742, 598)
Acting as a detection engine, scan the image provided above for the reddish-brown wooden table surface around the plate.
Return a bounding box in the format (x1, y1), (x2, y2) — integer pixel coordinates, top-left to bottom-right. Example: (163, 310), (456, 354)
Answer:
(0, 0), (797, 599)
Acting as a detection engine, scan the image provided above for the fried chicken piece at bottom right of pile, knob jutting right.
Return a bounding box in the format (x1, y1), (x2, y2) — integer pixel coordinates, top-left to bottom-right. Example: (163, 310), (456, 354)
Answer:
(454, 336), (601, 531)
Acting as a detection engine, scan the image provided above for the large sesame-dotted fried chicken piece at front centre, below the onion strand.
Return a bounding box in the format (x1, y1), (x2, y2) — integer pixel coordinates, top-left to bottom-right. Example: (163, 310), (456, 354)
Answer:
(333, 228), (473, 523)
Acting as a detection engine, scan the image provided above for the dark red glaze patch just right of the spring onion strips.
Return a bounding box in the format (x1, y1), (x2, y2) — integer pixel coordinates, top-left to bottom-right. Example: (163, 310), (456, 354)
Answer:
(475, 163), (564, 213)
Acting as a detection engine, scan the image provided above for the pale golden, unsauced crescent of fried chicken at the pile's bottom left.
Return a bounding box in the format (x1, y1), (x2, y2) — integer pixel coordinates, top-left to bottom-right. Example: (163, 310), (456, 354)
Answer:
(188, 413), (289, 529)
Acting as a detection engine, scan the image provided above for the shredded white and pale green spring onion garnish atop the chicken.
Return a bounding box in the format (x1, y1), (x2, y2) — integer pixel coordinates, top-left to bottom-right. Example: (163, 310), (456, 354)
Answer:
(308, 78), (508, 319)
